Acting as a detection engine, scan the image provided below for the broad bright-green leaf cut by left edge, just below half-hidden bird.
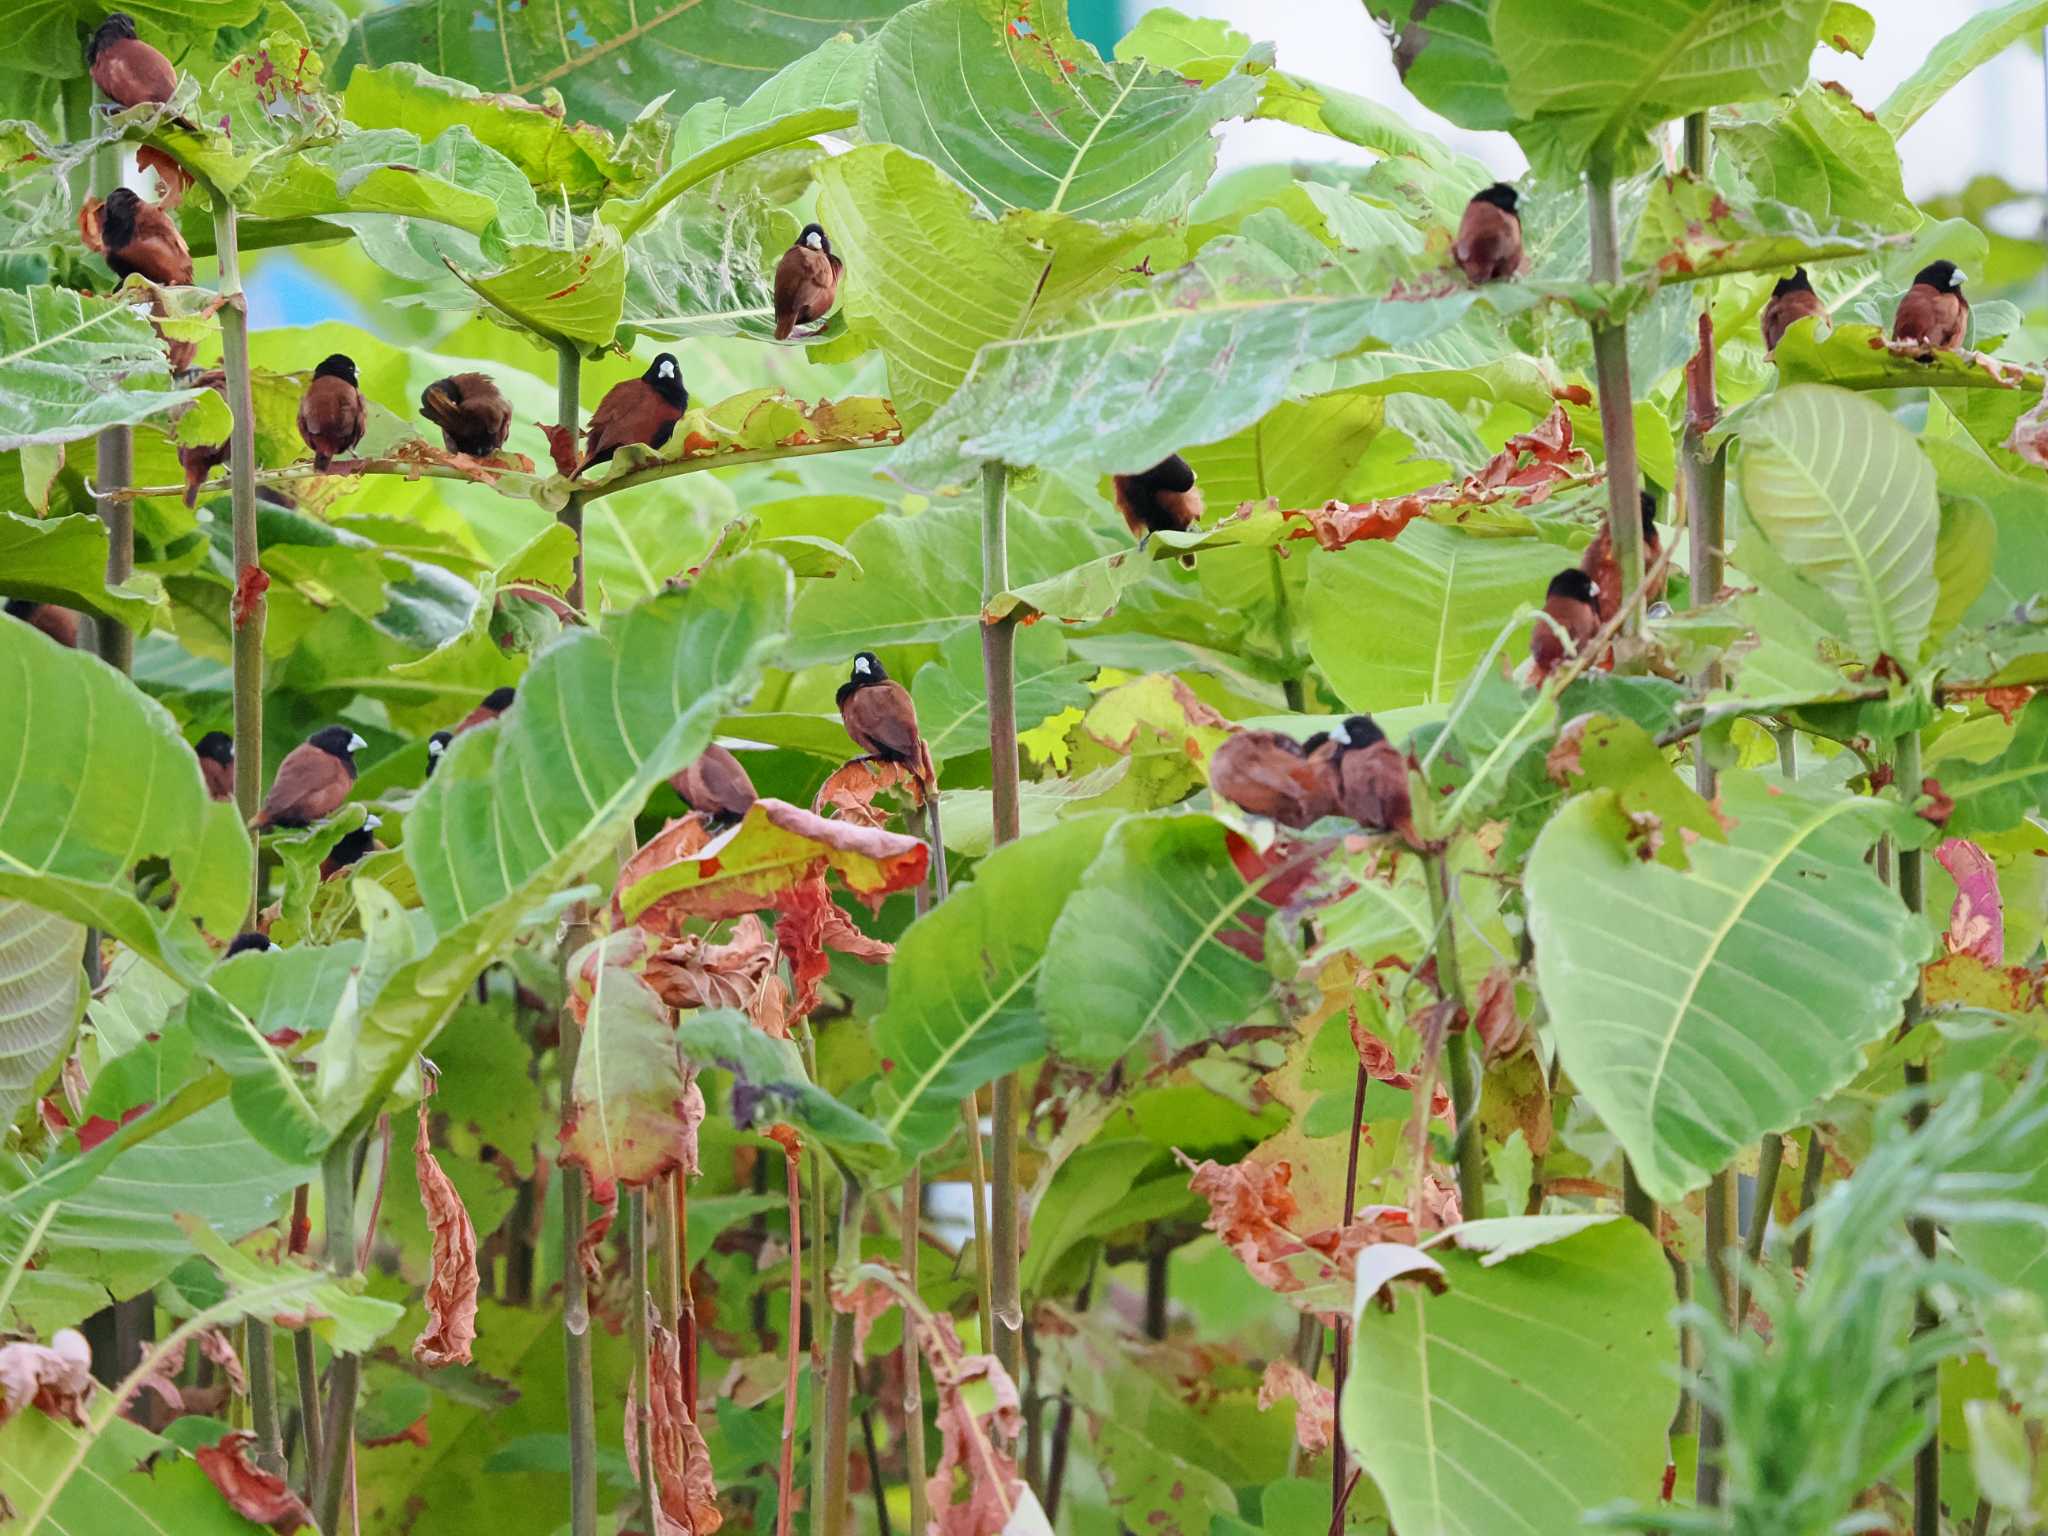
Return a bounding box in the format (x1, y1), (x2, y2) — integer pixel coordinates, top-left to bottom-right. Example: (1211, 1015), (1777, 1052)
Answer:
(0, 623), (252, 979)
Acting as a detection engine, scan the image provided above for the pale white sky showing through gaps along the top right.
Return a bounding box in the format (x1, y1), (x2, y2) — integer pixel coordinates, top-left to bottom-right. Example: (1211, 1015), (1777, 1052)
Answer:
(1187, 0), (2048, 199)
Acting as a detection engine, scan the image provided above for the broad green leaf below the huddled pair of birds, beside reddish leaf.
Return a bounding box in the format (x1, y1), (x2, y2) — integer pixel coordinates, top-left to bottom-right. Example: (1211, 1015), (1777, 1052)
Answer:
(1038, 815), (1272, 1065)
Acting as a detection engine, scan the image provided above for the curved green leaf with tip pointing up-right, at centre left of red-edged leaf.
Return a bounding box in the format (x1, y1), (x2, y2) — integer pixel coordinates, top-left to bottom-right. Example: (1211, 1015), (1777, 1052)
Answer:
(874, 815), (1114, 1157)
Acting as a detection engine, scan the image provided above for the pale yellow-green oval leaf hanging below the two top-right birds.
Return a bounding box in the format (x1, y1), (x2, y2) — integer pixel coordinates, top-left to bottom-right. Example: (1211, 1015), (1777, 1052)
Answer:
(1741, 385), (1942, 664)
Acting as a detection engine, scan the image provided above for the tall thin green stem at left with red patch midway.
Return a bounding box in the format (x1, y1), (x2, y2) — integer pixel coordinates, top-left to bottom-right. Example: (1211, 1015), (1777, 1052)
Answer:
(209, 188), (266, 901)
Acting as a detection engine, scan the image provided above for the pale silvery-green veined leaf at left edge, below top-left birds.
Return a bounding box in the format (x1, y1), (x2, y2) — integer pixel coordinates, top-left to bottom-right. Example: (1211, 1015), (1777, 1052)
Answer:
(0, 289), (199, 453)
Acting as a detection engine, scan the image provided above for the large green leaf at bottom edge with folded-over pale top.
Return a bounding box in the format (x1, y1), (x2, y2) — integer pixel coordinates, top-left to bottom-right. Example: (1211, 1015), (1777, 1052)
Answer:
(1343, 1219), (1677, 1536)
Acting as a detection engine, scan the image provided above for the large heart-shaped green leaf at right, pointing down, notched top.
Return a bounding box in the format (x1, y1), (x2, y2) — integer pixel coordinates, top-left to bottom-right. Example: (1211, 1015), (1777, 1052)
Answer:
(1528, 772), (1925, 1200)
